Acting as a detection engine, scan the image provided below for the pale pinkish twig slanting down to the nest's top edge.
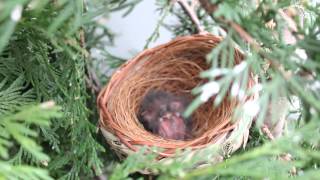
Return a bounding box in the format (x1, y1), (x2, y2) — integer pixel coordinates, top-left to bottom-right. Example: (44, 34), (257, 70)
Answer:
(177, 0), (205, 34)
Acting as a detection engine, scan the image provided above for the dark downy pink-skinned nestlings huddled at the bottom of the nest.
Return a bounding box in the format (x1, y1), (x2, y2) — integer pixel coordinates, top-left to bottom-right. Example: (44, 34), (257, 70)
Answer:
(138, 91), (192, 140)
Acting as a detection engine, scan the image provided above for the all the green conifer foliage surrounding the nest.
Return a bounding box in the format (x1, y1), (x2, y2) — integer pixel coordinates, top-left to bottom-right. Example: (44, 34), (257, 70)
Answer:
(0, 0), (320, 179)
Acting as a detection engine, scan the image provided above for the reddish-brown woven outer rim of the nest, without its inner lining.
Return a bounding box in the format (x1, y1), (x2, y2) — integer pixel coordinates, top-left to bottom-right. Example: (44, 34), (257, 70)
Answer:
(97, 34), (255, 158)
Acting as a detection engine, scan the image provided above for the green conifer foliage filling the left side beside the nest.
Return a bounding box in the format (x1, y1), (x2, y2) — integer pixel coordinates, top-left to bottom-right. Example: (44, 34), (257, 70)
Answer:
(0, 0), (139, 179)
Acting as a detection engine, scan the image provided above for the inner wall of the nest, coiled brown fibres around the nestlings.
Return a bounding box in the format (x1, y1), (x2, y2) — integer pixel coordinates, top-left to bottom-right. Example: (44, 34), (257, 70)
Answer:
(108, 45), (235, 144)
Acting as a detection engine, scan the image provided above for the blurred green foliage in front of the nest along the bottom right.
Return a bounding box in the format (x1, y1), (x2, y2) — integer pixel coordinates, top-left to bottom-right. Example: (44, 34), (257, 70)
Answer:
(111, 116), (320, 179)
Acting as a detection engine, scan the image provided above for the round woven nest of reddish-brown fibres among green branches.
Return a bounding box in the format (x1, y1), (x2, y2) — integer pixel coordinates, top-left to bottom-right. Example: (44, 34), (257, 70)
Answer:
(98, 34), (255, 158)
